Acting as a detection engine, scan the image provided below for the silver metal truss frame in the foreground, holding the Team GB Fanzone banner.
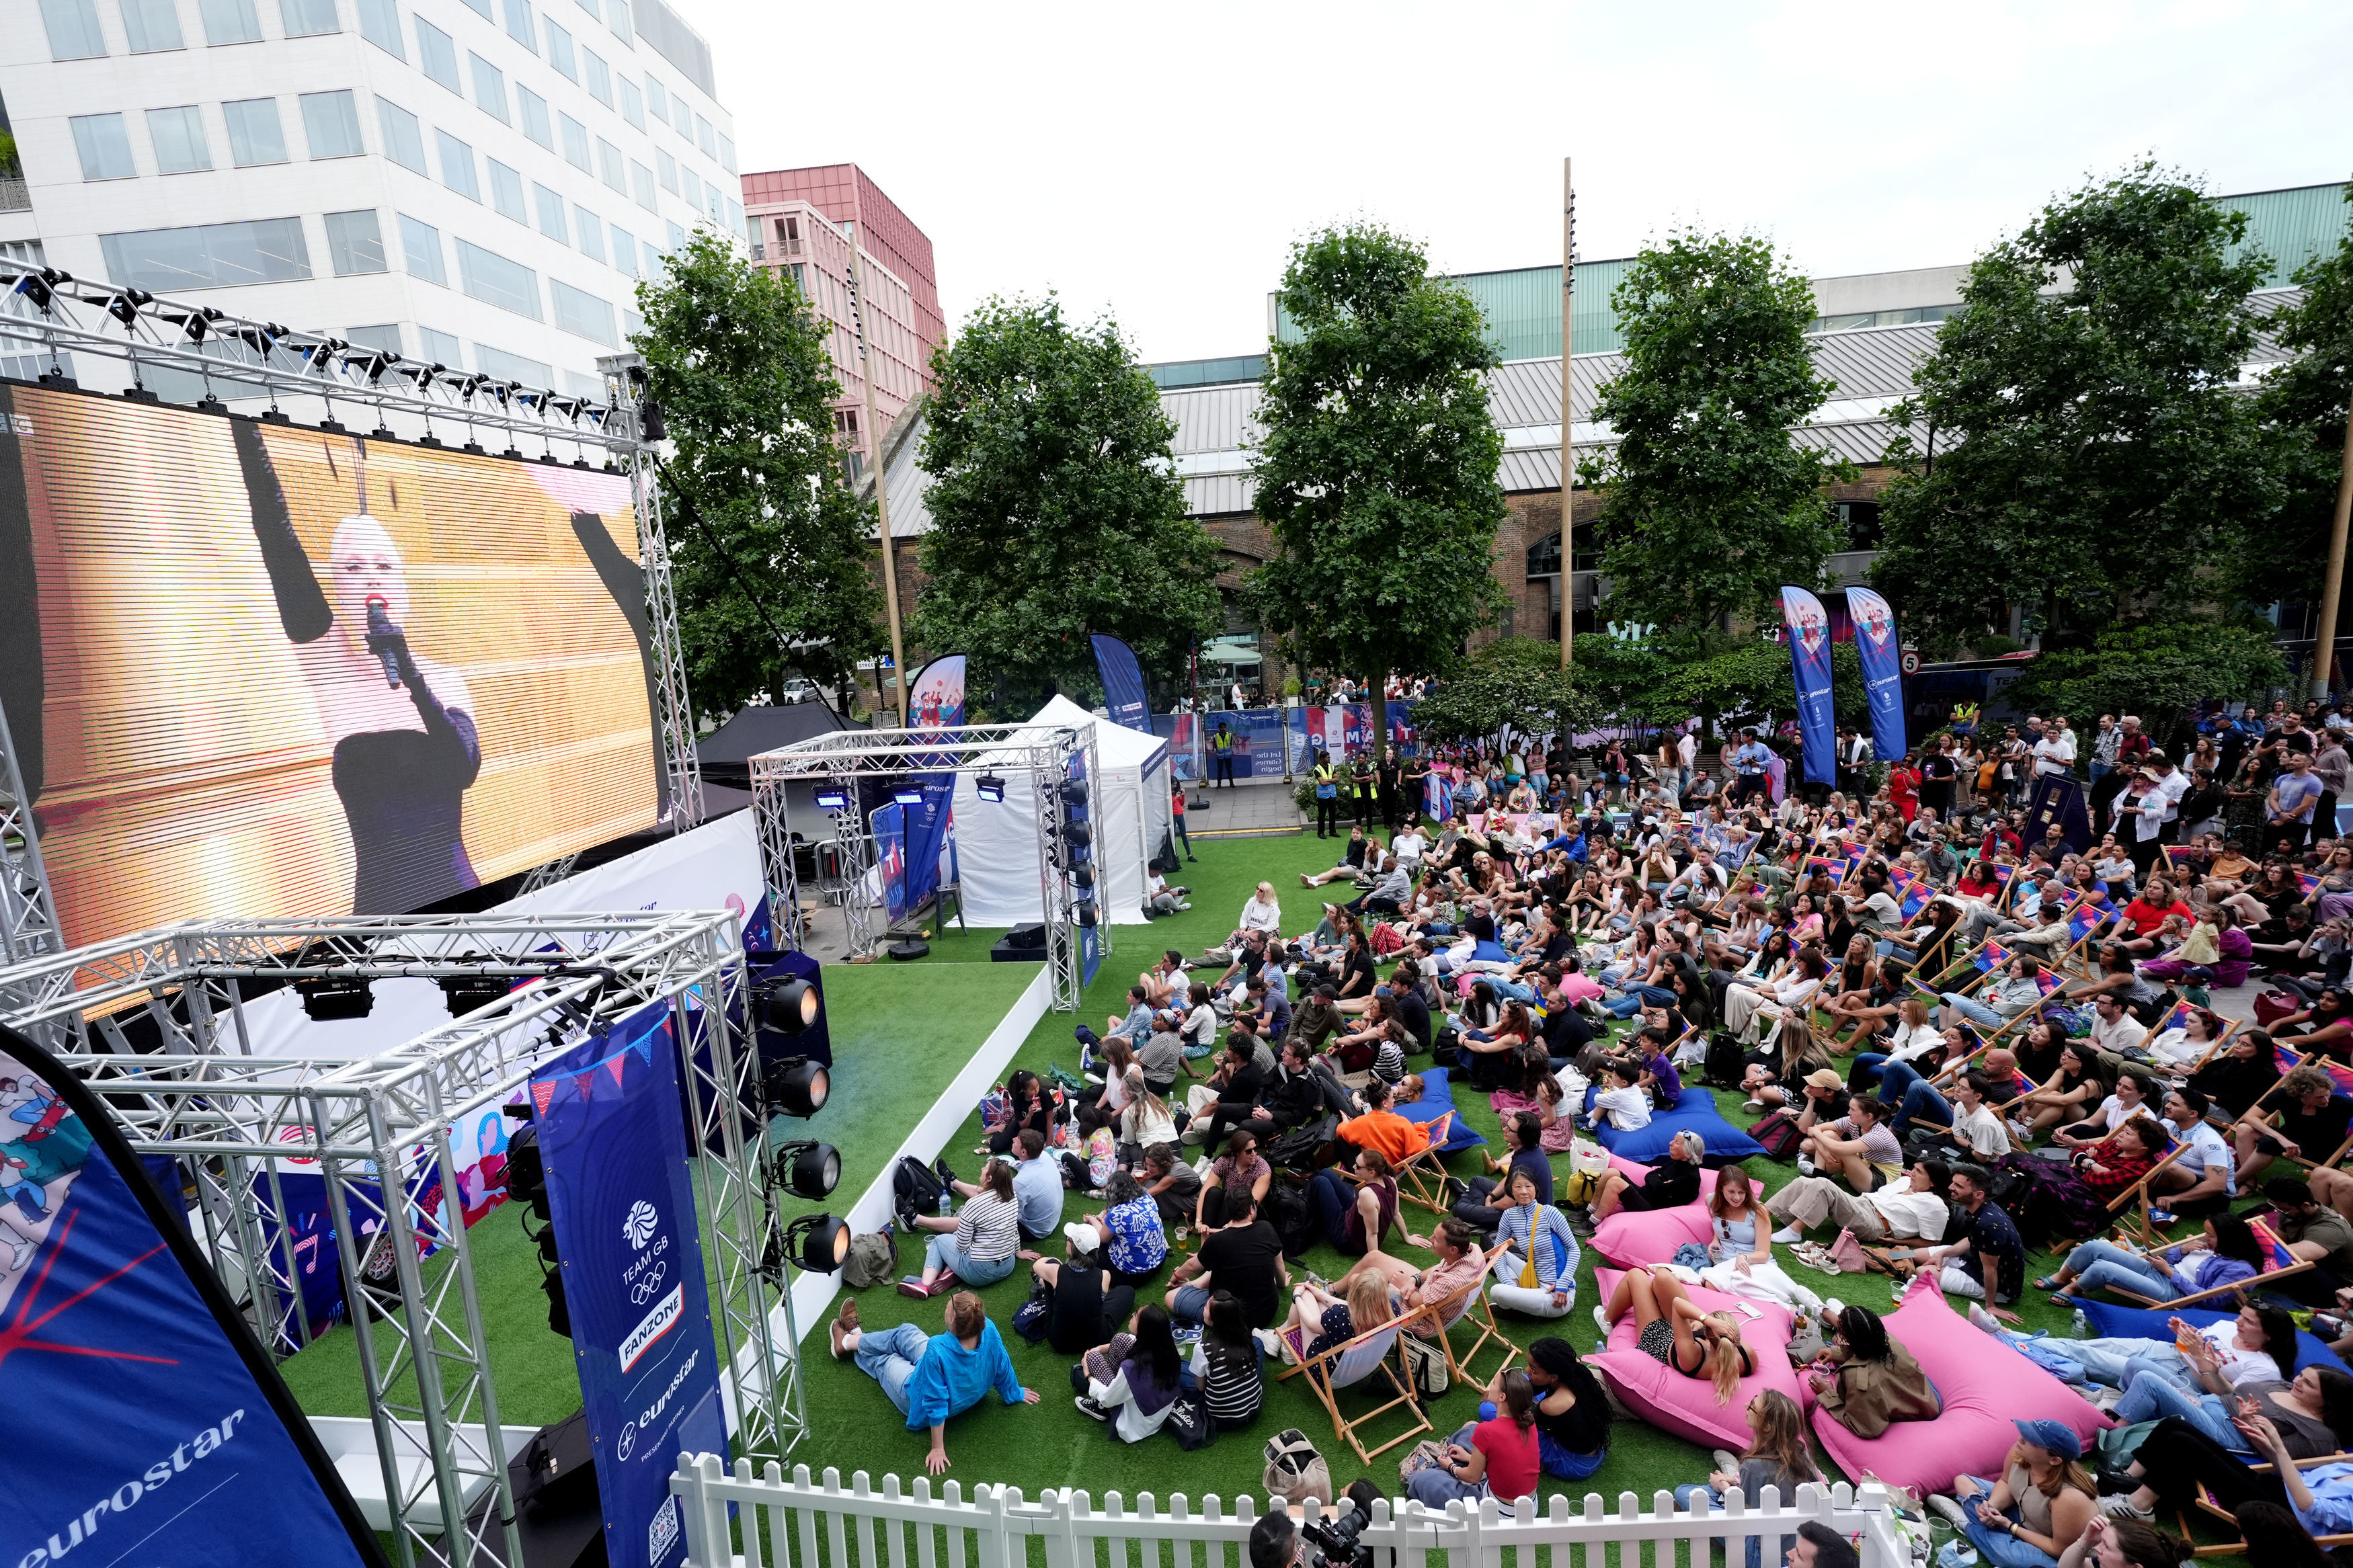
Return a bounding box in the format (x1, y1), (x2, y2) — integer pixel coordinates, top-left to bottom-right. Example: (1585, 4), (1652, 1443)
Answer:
(0, 912), (807, 1568)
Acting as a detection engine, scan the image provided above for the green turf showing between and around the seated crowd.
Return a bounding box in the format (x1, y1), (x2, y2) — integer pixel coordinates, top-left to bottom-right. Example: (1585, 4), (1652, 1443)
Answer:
(795, 832), (2137, 1505)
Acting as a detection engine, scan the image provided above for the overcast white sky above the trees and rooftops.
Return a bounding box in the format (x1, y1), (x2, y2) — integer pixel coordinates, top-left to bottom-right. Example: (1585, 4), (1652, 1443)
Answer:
(711, 0), (2353, 360)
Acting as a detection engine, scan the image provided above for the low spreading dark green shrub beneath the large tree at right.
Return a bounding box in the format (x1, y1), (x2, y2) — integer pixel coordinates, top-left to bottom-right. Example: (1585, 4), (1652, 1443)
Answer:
(2003, 620), (2311, 745)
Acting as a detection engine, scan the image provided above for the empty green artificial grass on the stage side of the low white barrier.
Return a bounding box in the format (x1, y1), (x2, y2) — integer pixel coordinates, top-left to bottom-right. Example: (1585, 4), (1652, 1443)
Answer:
(280, 964), (1035, 1427)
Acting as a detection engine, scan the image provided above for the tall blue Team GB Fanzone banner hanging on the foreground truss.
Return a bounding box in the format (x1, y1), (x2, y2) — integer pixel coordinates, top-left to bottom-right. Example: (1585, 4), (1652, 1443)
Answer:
(532, 1004), (727, 1568)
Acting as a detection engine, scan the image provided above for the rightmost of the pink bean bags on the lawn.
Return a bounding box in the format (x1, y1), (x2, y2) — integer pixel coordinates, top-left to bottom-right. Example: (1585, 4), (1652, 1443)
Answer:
(1805, 1279), (2116, 1497)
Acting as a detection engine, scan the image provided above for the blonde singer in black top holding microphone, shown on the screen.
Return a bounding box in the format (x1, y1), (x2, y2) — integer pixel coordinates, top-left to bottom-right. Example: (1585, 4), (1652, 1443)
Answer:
(233, 421), (483, 915)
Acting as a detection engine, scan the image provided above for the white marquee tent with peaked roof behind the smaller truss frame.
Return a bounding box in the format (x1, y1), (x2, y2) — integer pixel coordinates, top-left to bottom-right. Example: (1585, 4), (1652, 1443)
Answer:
(955, 696), (1174, 926)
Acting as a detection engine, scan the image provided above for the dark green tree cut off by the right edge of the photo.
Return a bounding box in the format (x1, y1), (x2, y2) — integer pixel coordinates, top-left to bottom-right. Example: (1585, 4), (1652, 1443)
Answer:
(2226, 183), (2353, 604)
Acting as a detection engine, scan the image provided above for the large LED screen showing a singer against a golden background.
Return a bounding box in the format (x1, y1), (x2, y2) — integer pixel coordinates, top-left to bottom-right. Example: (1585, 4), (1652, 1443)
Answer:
(0, 383), (662, 943)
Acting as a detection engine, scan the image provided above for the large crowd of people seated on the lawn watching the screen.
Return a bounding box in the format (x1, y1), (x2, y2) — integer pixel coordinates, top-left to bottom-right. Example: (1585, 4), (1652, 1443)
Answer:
(836, 714), (2353, 1568)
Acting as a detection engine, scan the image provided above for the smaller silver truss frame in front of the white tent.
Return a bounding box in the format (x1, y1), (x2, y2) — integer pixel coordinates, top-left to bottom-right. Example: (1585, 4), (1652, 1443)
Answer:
(751, 724), (1111, 1014)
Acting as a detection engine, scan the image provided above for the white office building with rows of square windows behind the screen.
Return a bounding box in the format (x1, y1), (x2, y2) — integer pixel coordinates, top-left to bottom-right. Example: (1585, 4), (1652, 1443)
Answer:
(0, 0), (744, 397)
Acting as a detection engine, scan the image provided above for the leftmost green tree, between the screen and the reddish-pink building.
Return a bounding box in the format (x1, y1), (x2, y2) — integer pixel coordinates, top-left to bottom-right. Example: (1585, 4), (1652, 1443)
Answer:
(631, 231), (883, 710)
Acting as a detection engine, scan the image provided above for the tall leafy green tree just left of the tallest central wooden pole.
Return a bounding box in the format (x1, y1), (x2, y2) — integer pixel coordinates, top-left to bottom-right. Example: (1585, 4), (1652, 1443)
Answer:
(1250, 223), (1504, 752)
